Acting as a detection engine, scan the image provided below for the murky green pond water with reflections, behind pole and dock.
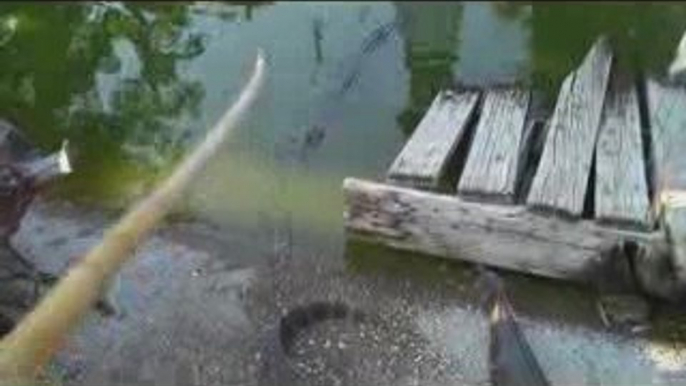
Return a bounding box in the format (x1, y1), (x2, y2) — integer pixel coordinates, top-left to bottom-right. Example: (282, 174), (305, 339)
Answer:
(0, 2), (686, 232)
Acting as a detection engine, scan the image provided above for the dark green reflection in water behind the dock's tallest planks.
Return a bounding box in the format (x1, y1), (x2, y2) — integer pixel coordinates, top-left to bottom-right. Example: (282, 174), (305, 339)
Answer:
(528, 2), (686, 101)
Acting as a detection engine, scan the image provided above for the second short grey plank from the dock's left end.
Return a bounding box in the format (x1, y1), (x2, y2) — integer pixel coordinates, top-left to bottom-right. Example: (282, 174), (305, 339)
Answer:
(457, 89), (530, 202)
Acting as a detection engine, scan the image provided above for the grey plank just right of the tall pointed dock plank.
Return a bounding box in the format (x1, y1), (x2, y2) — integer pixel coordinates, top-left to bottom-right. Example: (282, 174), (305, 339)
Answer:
(595, 79), (652, 230)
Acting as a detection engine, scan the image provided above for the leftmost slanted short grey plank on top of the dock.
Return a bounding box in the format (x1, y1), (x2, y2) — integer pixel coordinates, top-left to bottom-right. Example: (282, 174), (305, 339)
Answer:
(388, 91), (479, 188)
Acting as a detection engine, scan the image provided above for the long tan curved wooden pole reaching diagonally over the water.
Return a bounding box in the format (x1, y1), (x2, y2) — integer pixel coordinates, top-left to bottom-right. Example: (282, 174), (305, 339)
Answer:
(0, 51), (266, 384)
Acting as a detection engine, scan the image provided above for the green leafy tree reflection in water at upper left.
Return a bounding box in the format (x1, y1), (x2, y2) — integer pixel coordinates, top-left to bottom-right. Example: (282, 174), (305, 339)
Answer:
(0, 3), (236, 205)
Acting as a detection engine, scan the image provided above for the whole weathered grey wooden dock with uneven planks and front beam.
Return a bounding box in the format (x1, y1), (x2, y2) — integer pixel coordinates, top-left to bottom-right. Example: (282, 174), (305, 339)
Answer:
(343, 37), (686, 298)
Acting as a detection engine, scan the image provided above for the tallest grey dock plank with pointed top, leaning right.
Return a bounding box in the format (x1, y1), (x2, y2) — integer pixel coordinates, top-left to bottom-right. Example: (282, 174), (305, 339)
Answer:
(527, 38), (612, 217)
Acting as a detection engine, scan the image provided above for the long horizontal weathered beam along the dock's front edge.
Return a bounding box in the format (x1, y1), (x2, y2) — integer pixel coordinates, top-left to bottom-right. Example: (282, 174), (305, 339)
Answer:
(343, 178), (650, 281)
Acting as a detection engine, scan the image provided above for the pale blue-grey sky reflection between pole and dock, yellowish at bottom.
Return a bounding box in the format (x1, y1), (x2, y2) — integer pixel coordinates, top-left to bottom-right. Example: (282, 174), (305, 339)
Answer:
(183, 3), (405, 233)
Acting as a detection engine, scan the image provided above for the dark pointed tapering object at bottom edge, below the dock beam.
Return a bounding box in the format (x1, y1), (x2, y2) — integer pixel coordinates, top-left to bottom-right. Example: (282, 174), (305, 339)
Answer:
(481, 269), (549, 386)
